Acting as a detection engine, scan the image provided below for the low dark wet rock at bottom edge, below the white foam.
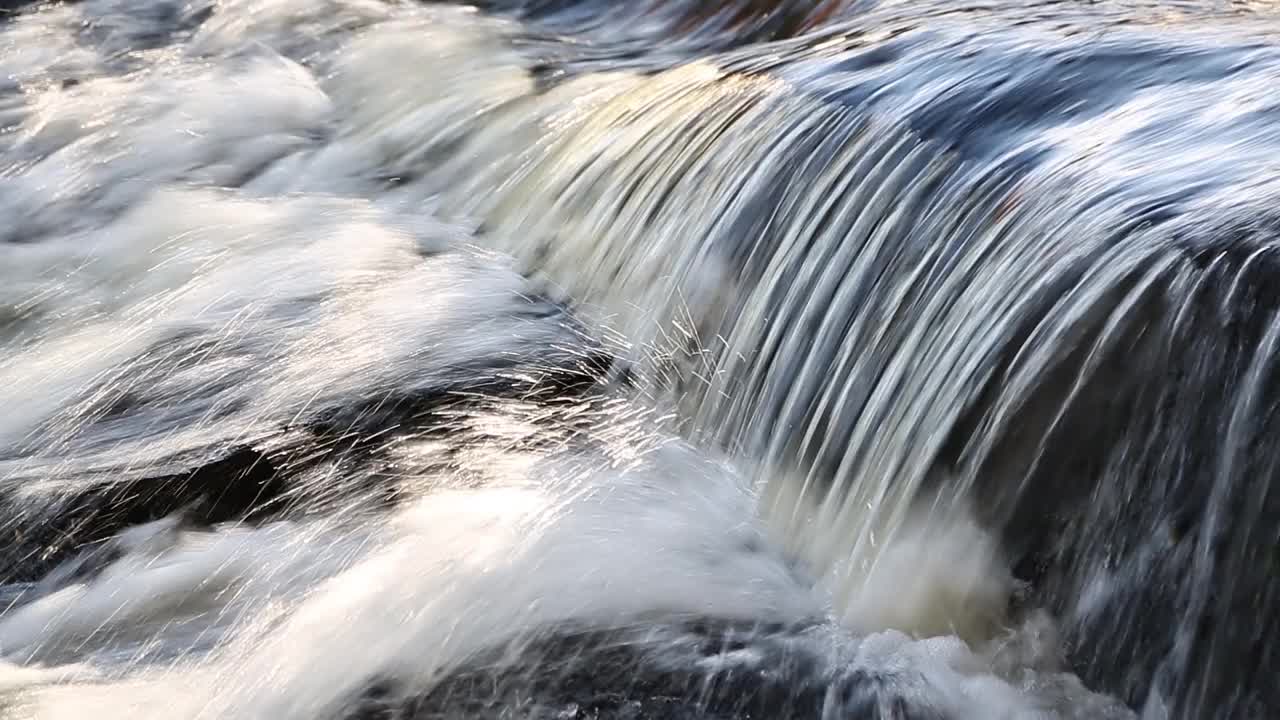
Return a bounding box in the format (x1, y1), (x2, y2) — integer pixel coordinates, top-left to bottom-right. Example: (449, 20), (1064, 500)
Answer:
(343, 620), (948, 720)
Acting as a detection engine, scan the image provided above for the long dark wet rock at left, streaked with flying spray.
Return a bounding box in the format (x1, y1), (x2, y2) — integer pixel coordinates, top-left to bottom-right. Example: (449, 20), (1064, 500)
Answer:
(0, 335), (624, 583)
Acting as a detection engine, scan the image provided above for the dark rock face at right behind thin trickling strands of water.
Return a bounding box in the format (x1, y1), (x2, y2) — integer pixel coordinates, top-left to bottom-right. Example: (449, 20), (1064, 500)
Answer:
(955, 220), (1280, 717)
